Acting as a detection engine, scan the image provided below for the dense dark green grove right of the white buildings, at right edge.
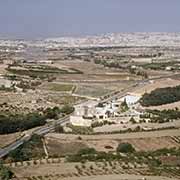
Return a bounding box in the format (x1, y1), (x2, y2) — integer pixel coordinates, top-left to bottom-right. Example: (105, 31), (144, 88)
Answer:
(140, 86), (180, 106)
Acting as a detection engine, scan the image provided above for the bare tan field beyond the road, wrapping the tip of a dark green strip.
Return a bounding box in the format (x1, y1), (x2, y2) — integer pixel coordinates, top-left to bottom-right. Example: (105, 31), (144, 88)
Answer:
(53, 60), (140, 81)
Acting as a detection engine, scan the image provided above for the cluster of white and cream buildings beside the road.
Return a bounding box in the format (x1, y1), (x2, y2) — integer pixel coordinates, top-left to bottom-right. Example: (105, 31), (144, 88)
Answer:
(70, 93), (141, 127)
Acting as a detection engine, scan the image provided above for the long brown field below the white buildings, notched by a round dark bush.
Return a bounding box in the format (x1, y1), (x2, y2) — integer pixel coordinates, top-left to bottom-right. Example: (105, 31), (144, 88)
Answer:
(45, 130), (180, 155)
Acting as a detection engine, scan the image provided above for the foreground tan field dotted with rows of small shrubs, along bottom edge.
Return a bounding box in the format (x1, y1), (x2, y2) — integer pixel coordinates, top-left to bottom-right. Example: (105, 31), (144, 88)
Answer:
(9, 159), (180, 180)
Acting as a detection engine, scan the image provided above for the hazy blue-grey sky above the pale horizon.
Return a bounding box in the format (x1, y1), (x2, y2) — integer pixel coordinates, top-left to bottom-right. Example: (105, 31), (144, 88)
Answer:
(0, 0), (180, 38)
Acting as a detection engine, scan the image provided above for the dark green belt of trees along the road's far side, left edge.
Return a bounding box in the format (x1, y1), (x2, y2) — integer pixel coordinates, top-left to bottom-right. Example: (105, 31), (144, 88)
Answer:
(0, 105), (74, 134)
